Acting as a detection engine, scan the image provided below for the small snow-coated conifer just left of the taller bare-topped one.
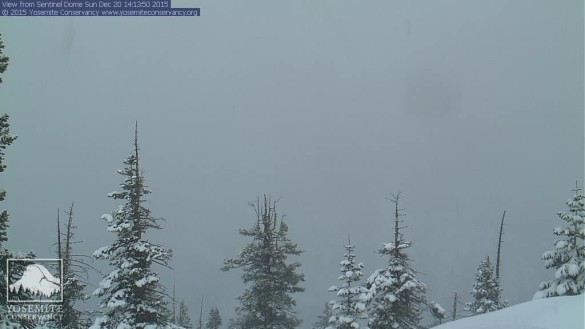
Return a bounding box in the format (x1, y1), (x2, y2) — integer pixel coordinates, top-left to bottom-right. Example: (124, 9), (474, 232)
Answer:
(328, 241), (368, 329)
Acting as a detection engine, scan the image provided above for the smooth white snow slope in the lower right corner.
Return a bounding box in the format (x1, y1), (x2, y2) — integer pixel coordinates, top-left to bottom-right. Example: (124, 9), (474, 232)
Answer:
(434, 295), (585, 329)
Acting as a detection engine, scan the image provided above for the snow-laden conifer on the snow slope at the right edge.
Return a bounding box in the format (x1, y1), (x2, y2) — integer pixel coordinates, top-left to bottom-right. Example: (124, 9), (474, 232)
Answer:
(535, 187), (585, 298)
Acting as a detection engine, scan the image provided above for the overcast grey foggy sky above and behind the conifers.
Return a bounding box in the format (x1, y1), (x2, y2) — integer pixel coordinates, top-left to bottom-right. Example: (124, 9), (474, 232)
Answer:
(0, 0), (584, 328)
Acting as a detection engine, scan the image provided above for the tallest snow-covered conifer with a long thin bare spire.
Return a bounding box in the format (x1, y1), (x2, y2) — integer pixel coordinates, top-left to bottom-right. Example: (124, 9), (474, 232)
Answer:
(92, 124), (171, 329)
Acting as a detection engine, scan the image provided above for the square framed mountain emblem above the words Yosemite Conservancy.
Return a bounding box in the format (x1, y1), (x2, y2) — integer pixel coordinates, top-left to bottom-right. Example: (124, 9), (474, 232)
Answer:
(6, 258), (63, 303)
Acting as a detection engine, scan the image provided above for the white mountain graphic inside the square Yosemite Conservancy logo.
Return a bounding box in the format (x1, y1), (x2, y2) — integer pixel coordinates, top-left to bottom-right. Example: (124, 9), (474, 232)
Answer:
(10, 264), (61, 297)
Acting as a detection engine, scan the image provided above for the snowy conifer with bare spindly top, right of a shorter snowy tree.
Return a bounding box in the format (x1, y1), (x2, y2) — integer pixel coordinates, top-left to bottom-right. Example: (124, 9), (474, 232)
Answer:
(365, 193), (427, 329)
